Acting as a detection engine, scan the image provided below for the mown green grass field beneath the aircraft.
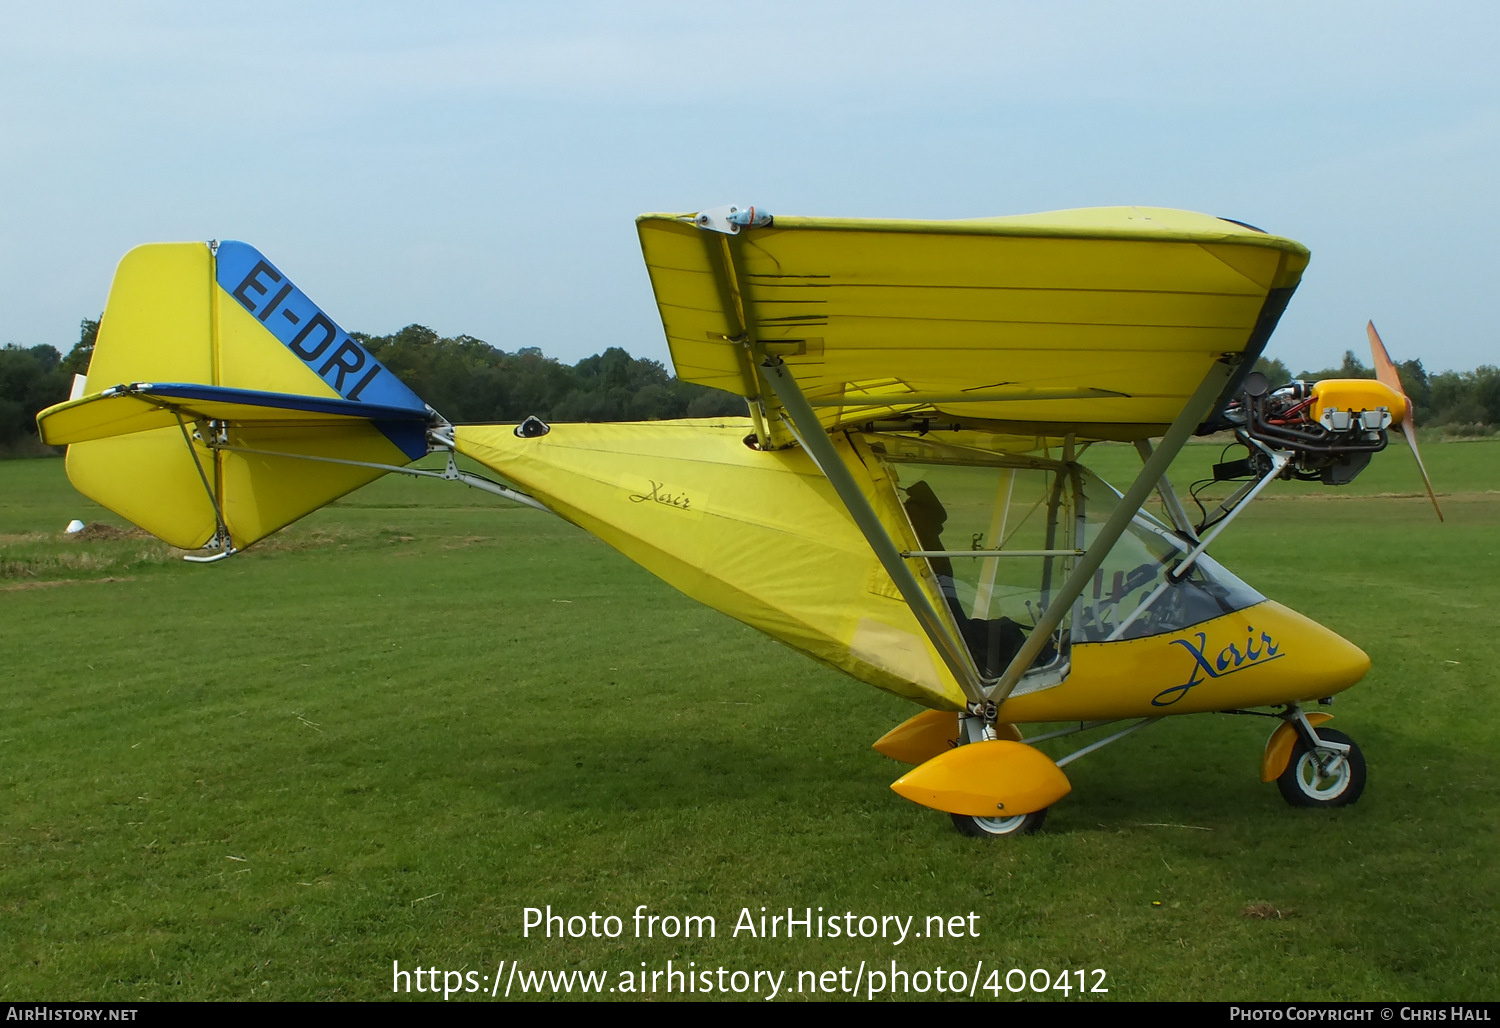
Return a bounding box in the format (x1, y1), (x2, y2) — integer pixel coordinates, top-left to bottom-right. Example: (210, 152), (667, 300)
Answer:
(0, 441), (1500, 1001)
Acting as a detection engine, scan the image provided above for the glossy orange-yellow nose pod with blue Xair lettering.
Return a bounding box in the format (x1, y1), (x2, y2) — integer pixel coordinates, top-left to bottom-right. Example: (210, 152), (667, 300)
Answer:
(1001, 600), (1370, 723)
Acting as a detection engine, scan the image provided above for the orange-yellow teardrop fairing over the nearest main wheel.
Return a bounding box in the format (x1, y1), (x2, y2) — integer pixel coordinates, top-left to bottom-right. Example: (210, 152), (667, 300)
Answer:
(891, 740), (1073, 818)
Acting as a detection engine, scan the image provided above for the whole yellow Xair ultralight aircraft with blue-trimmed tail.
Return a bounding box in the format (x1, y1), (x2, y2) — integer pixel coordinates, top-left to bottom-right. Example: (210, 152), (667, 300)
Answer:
(38, 207), (1437, 836)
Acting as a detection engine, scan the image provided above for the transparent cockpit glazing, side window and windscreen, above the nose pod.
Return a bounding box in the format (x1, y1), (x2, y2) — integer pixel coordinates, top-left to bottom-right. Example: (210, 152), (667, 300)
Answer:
(866, 435), (1265, 690)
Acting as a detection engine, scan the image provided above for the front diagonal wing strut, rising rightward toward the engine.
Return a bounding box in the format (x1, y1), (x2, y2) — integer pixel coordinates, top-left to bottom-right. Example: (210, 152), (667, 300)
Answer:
(986, 354), (1238, 704)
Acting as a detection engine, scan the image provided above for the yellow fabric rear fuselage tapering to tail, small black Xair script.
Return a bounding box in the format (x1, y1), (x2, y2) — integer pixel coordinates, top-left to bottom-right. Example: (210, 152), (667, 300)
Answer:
(455, 419), (963, 710)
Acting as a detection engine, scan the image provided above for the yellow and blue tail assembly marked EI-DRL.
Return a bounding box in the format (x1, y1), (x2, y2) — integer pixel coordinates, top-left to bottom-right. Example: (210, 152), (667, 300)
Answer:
(38, 242), (437, 554)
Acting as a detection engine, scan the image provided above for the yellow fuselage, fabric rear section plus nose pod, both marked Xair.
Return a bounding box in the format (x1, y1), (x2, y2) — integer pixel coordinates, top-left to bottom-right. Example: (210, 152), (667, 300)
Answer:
(455, 419), (1370, 723)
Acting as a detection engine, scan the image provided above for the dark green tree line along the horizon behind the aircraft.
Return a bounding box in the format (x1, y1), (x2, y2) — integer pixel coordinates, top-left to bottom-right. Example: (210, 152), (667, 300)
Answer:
(0, 318), (1500, 453)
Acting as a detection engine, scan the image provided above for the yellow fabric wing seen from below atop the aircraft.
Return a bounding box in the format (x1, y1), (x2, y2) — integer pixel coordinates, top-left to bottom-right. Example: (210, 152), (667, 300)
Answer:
(636, 207), (1308, 444)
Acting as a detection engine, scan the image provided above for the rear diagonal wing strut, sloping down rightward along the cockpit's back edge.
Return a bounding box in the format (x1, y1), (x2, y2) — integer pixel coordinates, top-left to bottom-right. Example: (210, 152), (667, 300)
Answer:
(761, 357), (984, 702)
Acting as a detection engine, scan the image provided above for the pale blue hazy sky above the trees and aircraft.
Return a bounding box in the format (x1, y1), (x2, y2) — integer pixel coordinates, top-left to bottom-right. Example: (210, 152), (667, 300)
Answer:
(0, 0), (1500, 372)
